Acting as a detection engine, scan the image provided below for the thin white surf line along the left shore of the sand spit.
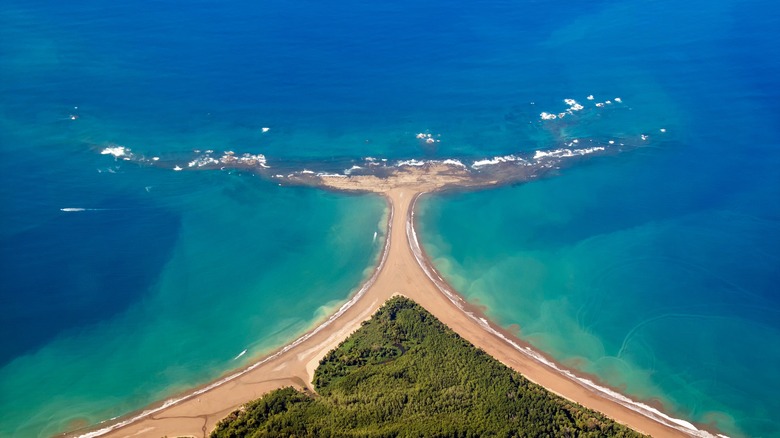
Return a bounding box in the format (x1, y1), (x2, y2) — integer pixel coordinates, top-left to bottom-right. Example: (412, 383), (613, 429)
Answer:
(78, 199), (395, 438)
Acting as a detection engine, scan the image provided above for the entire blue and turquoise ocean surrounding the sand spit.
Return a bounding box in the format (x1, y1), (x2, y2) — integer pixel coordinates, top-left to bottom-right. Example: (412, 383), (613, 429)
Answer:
(0, 0), (780, 437)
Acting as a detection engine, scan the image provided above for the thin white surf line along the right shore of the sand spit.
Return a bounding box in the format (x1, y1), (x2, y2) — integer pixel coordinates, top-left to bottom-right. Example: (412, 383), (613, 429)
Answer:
(406, 192), (725, 438)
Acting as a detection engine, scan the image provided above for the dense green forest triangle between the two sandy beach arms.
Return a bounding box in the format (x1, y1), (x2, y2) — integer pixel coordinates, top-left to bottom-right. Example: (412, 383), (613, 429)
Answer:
(212, 298), (641, 438)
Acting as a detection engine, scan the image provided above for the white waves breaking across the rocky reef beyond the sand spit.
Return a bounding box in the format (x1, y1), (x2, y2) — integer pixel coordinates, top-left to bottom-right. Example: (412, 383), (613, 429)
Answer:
(94, 94), (666, 191)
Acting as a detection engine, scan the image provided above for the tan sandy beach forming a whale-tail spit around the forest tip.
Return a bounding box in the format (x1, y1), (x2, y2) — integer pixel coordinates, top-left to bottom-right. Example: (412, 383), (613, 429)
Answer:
(77, 166), (707, 437)
